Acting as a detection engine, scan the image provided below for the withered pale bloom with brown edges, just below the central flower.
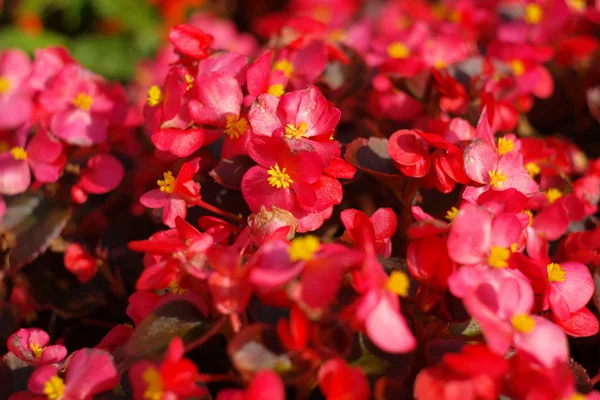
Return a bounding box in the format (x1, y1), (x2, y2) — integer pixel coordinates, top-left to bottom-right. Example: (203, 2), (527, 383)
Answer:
(248, 206), (298, 244)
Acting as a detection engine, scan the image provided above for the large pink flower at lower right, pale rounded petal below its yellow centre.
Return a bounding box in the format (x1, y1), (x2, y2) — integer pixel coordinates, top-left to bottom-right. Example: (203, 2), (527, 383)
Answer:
(449, 267), (569, 367)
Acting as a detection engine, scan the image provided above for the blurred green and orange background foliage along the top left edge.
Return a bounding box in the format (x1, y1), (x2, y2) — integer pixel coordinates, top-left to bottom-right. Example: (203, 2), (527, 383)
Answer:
(0, 0), (286, 82)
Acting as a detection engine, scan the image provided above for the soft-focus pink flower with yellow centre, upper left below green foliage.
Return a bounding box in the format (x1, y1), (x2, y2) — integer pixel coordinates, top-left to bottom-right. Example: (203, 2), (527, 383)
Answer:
(39, 64), (114, 146)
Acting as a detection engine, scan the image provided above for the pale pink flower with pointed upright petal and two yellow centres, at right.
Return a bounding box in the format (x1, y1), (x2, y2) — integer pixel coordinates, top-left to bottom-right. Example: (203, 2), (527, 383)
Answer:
(463, 110), (538, 200)
